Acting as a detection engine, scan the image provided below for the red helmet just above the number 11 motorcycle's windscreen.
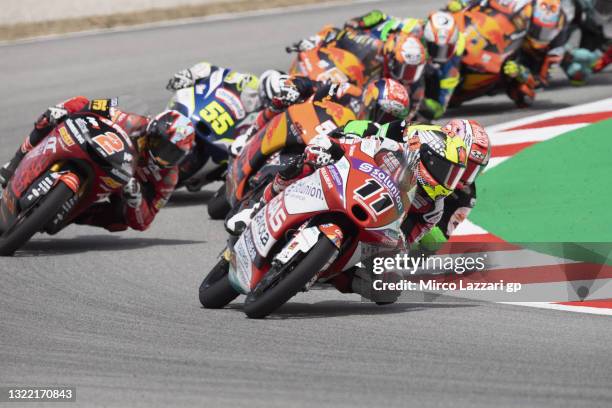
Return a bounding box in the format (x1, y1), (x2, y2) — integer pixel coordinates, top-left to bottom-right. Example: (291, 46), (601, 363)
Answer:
(362, 78), (410, 124)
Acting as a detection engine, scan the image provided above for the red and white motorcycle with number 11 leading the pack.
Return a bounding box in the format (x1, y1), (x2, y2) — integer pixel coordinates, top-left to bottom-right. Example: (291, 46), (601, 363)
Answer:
(199, 139), (412, 318)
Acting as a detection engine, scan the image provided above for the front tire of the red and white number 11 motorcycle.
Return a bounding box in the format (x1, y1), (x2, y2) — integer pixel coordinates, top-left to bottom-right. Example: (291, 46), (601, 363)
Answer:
(244, 236), (338, 319)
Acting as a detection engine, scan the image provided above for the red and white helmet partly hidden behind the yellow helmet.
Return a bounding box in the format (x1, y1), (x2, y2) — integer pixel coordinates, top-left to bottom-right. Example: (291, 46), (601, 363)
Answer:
(444, 119), (491, 185)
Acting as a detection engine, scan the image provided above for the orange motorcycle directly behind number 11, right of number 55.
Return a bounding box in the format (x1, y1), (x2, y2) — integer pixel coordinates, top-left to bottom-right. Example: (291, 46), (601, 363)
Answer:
(209, 100), (355, 217)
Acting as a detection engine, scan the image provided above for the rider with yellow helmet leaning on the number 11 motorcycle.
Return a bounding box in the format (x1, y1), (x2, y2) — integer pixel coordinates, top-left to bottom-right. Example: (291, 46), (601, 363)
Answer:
(226, 121), (467, 299)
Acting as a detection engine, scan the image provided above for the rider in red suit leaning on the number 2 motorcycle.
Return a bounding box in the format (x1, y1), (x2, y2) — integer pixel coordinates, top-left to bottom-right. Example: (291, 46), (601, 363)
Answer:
(0, 96), (195, 232)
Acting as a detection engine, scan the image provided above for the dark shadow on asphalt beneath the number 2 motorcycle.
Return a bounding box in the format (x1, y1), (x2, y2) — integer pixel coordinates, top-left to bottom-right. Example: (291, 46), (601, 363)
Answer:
(15, 235), (205, 258)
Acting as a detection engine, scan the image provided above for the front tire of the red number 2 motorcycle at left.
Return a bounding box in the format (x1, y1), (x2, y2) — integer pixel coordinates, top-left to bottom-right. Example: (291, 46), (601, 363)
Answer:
(0, 182), (74, 256)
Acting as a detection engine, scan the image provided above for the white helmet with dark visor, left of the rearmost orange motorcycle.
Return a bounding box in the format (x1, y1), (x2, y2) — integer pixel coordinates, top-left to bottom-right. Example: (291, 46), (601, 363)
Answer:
(423, 11), (460, 64)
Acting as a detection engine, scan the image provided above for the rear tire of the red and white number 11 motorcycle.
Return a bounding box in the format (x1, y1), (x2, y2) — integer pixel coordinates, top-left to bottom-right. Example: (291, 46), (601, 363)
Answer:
(200, 258), (239, 309)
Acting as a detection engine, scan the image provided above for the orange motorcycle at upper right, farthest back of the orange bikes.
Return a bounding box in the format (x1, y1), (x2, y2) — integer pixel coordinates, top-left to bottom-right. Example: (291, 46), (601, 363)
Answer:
(450, 9), (535, 107)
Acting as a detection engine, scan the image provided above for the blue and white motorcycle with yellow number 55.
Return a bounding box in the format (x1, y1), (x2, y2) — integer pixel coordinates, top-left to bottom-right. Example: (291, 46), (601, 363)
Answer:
(168, 69), (256, 210)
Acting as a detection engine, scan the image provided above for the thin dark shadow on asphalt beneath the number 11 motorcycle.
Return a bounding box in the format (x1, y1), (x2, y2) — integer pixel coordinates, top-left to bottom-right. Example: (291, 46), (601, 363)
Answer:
(222, 300), (479, 320)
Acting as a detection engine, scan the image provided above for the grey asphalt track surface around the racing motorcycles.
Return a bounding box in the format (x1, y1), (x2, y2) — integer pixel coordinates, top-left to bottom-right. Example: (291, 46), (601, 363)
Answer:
(0, 0), (612, 407)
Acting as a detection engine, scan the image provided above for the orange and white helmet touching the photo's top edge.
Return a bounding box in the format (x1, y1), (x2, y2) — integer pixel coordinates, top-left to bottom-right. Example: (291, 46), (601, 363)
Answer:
(527, 0), (564, 50)
